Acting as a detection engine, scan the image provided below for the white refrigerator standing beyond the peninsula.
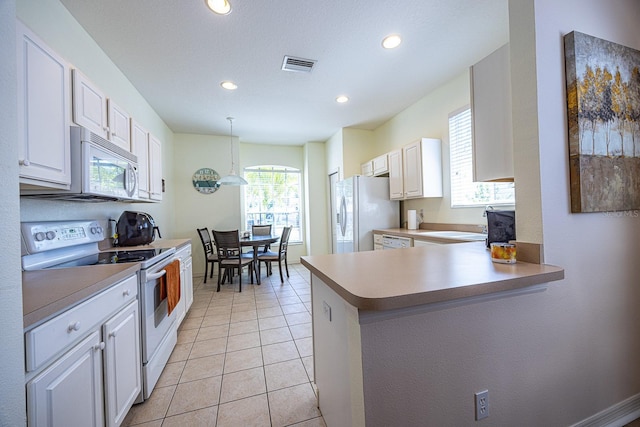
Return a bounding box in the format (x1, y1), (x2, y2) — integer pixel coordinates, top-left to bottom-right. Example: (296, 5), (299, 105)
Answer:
(333, 175), (400, 253)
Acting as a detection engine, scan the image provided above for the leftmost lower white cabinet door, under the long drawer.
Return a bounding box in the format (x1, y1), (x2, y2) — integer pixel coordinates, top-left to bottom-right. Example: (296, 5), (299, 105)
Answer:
(27, 331), (104, 427)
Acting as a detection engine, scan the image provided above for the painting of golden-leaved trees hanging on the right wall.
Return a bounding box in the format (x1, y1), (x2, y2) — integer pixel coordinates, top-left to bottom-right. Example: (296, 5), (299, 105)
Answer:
(564, 31), (640, 213)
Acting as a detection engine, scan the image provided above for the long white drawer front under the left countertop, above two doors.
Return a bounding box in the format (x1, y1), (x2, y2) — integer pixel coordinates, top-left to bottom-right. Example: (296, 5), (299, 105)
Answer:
(25, 276), (138, 372)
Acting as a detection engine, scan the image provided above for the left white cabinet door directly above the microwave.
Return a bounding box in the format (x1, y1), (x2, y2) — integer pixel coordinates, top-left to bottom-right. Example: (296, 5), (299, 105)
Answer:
(73, 69), (109, 139)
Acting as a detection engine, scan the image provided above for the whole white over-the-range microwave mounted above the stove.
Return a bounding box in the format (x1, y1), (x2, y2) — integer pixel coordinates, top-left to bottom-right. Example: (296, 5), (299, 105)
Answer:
(20, 126), (138, 202)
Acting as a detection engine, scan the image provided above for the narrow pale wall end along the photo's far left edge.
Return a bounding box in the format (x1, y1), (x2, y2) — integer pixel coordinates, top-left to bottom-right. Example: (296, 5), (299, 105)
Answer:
(0, 0), (26, 426)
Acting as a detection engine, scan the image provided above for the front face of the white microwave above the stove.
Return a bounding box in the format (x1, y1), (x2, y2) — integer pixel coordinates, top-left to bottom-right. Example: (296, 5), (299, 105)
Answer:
(82, 141), (138, 199)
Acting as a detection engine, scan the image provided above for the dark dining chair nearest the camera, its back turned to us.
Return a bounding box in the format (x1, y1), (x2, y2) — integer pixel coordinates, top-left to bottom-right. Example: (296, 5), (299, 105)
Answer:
(213, 230), (257, 292)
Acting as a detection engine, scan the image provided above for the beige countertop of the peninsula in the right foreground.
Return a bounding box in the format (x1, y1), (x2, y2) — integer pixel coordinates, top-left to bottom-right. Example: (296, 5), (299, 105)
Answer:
(301, 244), (564, 310)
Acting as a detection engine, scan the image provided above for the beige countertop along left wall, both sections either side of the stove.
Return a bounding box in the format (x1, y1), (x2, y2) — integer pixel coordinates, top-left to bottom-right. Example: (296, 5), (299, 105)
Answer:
(22, 239), (191, 329)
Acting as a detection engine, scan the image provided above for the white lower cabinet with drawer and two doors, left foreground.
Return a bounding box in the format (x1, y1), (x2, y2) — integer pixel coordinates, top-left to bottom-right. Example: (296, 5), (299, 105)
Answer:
(25, 275), (142, 427)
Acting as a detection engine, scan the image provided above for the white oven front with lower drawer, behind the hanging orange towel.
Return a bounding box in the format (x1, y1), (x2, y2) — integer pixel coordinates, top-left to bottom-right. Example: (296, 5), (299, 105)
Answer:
(140, 256), (178, 399)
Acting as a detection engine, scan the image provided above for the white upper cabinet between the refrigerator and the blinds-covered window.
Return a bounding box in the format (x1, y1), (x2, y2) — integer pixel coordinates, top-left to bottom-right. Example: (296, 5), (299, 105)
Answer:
(402, 138), (442, 199)
